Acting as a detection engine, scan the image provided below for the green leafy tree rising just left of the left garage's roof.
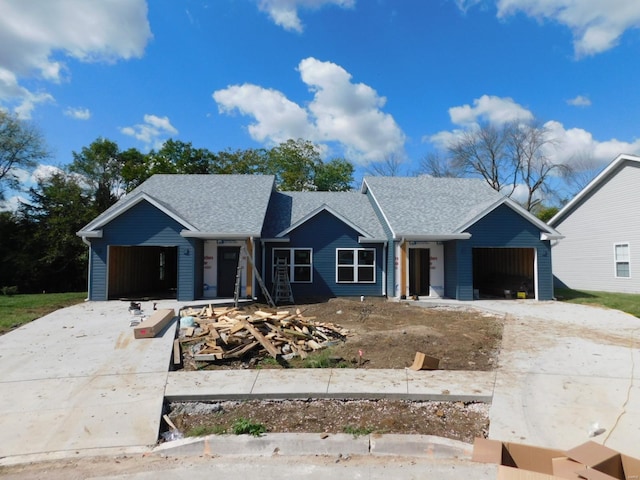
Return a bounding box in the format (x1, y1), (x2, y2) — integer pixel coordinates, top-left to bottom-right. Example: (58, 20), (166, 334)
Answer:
(69, 137), (125, 212)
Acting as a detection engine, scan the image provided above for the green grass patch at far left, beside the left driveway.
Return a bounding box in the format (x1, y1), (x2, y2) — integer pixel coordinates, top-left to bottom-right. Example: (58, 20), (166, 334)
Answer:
(0, 292), (87, 334)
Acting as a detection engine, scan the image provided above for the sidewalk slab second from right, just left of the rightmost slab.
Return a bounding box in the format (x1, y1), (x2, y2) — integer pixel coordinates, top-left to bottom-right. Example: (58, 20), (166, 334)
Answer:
(327, 368), (408, 398)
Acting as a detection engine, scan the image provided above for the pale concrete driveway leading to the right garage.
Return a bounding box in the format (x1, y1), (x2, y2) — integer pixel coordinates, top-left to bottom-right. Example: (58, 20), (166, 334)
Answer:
(464, 301), (640, 457)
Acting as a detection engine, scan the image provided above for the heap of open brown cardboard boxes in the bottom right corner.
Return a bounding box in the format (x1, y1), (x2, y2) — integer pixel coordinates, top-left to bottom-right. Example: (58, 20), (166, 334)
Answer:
(472, 438), (640, 480)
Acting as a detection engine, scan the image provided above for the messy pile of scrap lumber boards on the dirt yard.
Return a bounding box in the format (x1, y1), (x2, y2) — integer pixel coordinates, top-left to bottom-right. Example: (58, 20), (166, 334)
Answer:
(174, 305), (349, 363)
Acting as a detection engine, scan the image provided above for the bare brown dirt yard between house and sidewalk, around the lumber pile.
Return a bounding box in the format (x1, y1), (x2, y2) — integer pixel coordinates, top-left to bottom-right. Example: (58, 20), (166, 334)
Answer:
(184, 298), (503, 371)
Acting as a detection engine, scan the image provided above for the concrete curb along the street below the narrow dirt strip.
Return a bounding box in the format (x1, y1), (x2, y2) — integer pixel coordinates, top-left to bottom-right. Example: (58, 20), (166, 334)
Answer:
(153, 433), (473, 460)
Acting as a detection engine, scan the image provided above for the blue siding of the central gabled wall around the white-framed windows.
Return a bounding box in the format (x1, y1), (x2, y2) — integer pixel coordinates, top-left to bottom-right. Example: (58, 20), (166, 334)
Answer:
(265, 211), (384, 298)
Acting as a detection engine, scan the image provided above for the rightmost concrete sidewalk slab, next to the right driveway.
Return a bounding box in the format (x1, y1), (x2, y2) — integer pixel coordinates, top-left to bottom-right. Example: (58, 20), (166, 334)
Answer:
(406, 369), (496, 403)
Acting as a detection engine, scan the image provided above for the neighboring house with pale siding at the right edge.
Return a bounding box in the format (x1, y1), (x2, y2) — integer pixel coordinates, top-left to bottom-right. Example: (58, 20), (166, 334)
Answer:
(549, 155), (640, 293)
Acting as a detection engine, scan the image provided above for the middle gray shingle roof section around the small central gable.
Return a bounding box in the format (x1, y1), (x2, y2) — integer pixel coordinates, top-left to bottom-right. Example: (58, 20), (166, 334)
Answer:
(264, 192), (385, 239)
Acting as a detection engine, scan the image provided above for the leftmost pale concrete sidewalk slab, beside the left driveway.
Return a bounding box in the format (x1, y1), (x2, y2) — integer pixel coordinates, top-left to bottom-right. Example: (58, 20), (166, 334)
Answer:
(165, 370), (259, 401)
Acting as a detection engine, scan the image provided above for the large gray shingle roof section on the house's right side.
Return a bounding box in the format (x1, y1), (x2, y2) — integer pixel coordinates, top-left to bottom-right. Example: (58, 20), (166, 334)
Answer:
(363, 176), (505, 236)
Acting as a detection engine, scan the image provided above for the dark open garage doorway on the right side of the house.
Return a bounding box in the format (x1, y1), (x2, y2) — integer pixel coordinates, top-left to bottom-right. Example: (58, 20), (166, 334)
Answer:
(473, 248), (536, 298)
